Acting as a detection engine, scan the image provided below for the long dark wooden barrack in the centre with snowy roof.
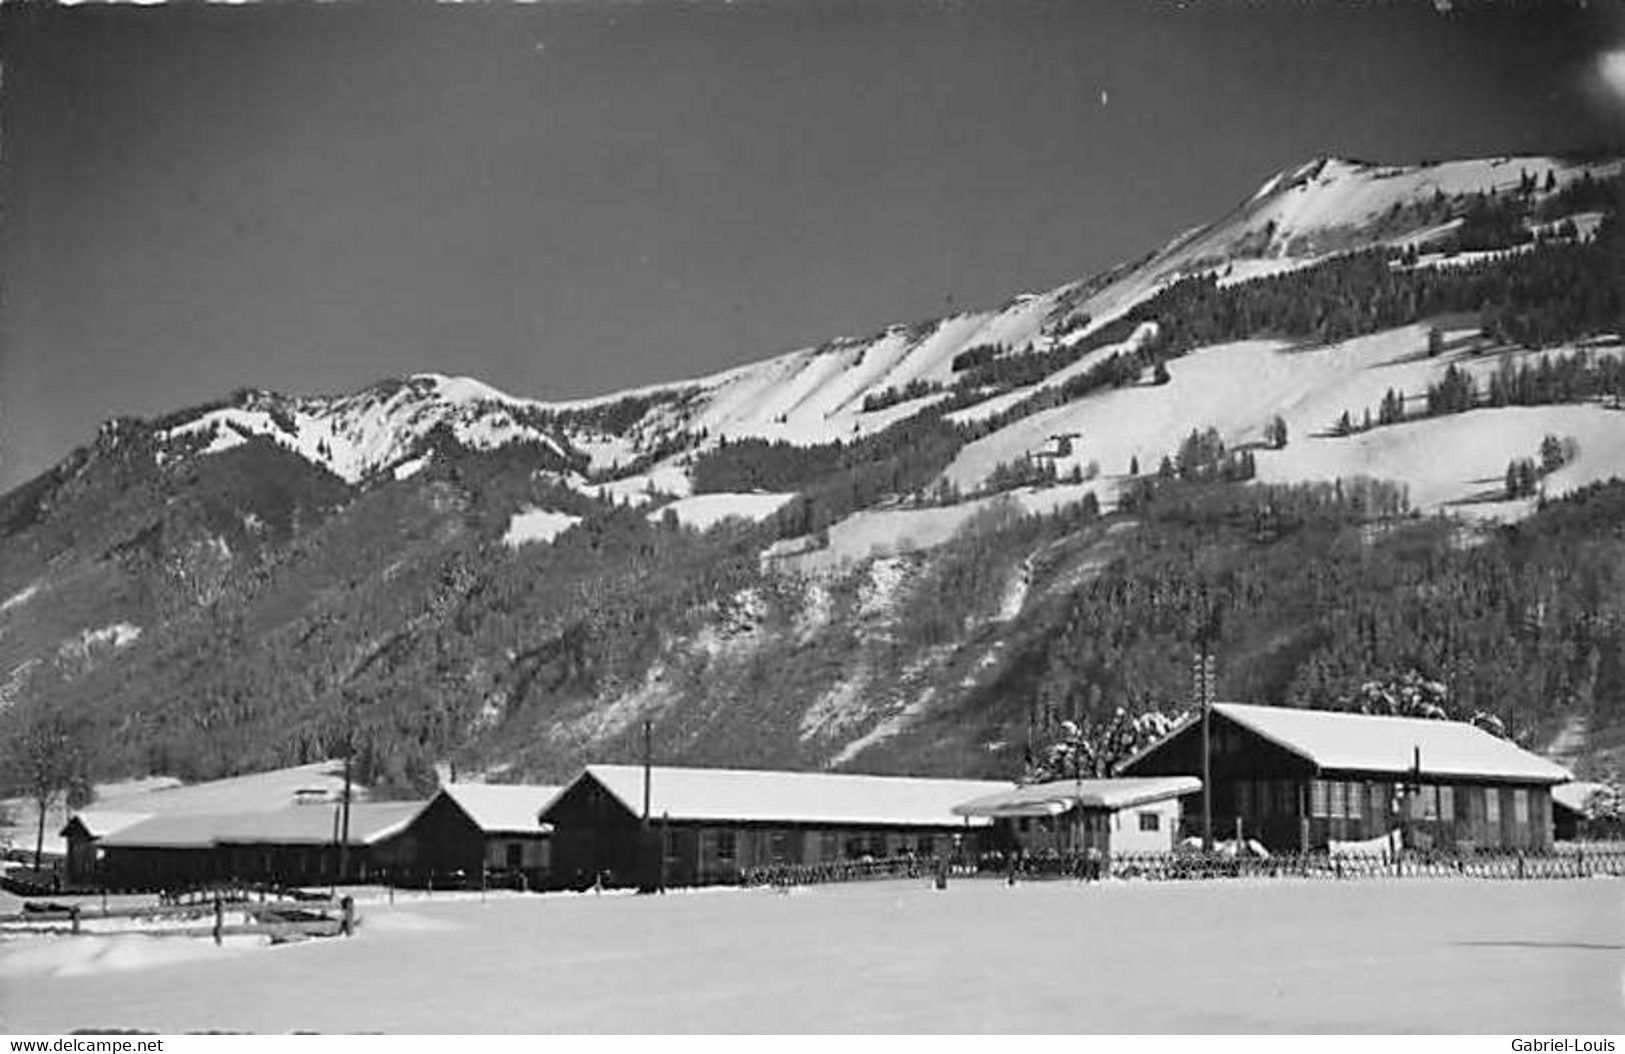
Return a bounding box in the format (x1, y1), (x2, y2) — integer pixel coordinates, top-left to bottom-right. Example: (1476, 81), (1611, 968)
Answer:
(540, 765), (1012, 888)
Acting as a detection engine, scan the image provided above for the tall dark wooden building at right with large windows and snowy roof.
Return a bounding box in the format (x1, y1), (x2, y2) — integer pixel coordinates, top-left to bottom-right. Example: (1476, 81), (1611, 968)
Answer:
(1120, 703), (1570, 851)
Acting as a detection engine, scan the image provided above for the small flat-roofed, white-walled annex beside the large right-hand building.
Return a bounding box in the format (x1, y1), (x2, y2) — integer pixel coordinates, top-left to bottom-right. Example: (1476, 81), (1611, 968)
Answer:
(954, 776), (1203, 853)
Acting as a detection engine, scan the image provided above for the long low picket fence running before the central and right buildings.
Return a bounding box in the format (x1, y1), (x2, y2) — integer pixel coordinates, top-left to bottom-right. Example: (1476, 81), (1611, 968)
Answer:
(739, 844), (1625, 887)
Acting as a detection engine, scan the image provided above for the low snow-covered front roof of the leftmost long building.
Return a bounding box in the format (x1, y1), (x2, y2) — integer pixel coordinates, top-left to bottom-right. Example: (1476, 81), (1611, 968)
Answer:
(101, 802), (424, 849)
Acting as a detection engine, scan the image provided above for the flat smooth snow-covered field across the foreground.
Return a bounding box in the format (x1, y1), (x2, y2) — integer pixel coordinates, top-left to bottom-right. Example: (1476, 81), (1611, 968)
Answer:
(0, 880), (1625, 1035)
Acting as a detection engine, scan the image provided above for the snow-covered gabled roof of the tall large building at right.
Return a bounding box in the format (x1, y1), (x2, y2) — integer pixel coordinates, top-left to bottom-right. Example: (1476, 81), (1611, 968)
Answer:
(1120, 703), (1573, 783)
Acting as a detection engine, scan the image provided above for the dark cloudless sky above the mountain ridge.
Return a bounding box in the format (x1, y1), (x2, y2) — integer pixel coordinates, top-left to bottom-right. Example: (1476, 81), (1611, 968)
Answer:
(0, 0), (1625, 490)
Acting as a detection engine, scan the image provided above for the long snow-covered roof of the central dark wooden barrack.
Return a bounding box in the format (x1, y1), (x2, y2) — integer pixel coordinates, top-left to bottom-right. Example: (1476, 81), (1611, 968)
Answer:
(565, 765), (1012, 827)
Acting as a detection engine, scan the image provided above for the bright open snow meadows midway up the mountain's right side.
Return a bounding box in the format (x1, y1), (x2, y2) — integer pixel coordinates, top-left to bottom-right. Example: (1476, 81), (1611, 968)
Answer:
(942, 325), (1625, 513)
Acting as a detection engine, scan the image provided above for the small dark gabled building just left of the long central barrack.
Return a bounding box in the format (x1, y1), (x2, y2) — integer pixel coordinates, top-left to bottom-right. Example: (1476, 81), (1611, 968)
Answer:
(397, 783), (564, 888)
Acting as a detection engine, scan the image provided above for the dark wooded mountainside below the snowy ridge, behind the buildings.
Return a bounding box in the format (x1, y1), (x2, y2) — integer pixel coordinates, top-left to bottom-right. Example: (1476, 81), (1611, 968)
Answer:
(0, 179), (1625, 794)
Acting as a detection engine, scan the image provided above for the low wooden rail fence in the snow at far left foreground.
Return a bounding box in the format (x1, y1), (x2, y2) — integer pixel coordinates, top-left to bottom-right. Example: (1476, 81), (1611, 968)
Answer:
(0, 896), (358, 944)
